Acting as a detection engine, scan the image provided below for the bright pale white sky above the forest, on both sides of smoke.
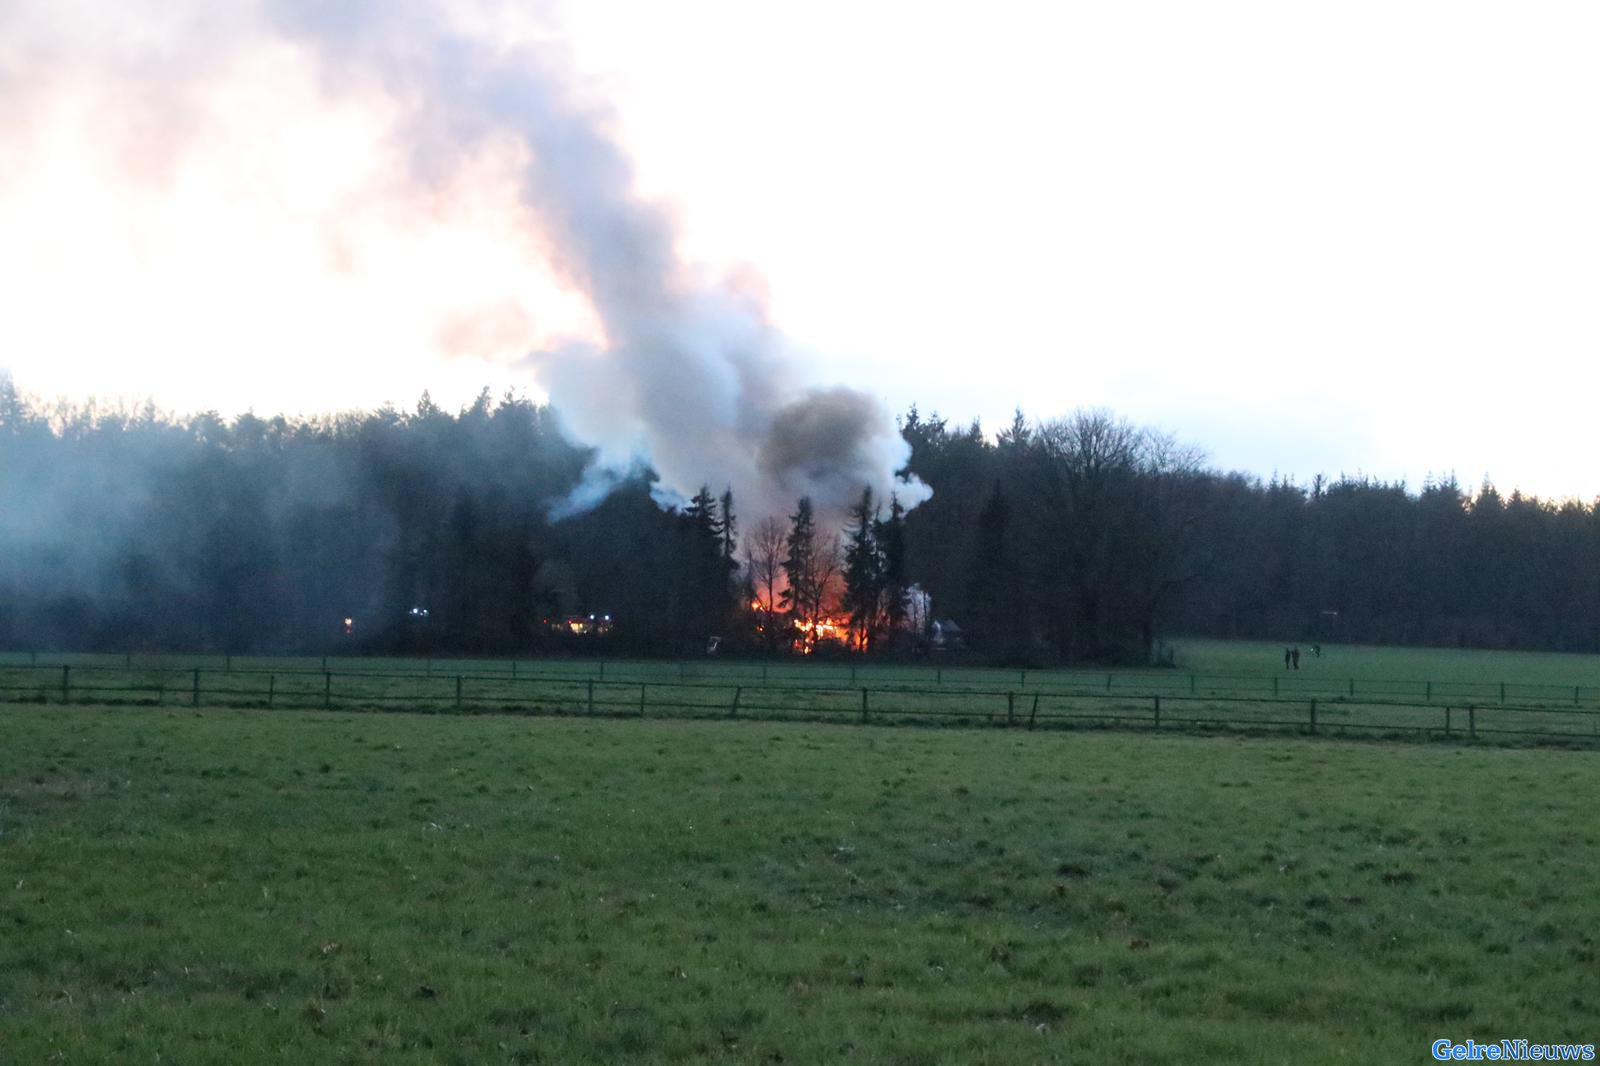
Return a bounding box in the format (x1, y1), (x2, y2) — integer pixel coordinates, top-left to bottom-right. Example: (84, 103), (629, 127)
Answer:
(0, 0), (1600, 499)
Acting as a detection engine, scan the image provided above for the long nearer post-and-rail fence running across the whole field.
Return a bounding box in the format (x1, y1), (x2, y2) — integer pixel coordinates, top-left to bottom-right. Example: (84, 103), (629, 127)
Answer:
(0, 664), (1600, 743)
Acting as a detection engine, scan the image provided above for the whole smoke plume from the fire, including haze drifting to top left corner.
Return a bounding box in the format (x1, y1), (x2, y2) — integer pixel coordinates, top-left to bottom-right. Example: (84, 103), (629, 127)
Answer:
(0, 0), (928, 517)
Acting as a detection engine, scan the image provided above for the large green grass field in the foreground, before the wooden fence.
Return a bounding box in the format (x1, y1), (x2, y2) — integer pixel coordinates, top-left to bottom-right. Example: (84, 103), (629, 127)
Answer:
(0, 706), (1600, 1063)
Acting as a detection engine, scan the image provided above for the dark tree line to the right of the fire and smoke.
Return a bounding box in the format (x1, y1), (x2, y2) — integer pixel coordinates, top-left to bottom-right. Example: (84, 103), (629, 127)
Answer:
(902, 410), (1600, 661)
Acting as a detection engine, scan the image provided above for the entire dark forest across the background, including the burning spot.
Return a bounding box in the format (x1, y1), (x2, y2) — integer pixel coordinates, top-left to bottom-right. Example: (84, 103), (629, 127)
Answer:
(0, 375), (1600, 666)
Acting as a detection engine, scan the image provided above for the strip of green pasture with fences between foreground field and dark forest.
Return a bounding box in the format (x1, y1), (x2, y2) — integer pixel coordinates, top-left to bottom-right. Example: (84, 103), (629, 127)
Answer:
(9, 640), (1600, 744)
